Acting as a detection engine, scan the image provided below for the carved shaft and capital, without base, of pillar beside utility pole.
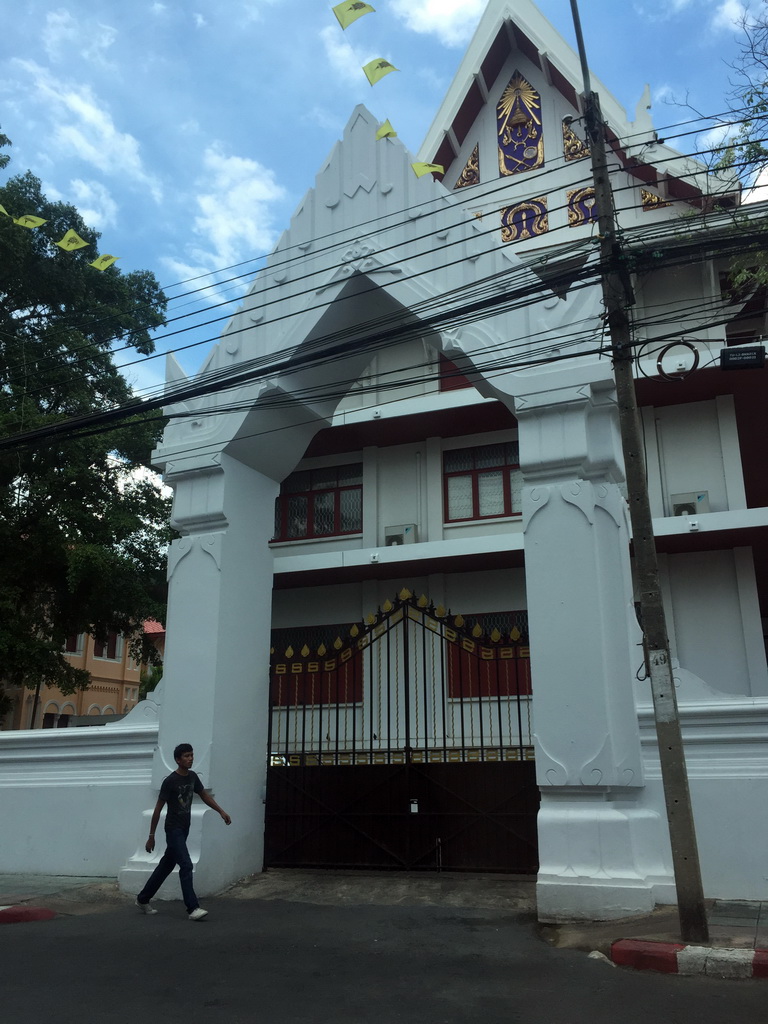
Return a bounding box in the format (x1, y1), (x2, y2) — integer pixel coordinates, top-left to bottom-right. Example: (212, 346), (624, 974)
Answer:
(515, 376), (643, 791)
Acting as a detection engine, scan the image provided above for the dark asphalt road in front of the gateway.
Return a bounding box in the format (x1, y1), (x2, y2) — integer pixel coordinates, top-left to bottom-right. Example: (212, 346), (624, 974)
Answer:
(0, 898), (768, 1024)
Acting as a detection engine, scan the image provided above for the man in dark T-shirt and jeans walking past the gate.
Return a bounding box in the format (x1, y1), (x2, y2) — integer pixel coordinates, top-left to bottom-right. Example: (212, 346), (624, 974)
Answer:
(136, 743), (231, 921)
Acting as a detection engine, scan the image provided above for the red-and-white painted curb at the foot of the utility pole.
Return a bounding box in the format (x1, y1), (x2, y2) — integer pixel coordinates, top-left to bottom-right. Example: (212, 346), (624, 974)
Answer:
(610, 939), (768, 978)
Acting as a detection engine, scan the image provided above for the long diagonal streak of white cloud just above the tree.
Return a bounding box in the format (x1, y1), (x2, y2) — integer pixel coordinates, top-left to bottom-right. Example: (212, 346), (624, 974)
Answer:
(15, 60), (162, 203)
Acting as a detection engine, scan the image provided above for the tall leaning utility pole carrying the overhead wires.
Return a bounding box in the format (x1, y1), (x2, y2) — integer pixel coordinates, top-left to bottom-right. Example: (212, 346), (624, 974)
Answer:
(570, 0), (710, 942)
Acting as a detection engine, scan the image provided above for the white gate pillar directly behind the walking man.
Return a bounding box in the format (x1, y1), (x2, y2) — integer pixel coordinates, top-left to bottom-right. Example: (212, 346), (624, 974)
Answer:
(120, 455), (279, 899)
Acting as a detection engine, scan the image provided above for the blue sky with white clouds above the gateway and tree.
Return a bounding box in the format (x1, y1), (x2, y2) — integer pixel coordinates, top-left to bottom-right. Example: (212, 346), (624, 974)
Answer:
(0, 0), (763, 393)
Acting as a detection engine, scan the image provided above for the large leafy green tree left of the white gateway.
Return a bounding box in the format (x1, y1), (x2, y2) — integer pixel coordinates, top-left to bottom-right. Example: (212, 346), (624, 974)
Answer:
(0, 146), (170, 693)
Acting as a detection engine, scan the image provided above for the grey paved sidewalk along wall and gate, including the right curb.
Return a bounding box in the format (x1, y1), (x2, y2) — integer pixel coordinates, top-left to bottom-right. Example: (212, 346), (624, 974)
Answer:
(0, 869), (768, 977)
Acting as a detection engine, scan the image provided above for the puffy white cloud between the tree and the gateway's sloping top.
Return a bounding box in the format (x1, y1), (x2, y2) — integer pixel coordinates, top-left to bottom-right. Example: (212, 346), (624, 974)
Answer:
(186, 143), (286, 265)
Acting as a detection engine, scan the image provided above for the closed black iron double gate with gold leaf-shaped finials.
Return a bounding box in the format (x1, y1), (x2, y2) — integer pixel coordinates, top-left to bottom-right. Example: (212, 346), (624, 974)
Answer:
(264, 590), (539, 873)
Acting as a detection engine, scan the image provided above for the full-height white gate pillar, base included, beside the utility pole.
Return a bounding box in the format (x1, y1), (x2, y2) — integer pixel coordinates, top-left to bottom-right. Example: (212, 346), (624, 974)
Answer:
(514, 365), (675, 921)
